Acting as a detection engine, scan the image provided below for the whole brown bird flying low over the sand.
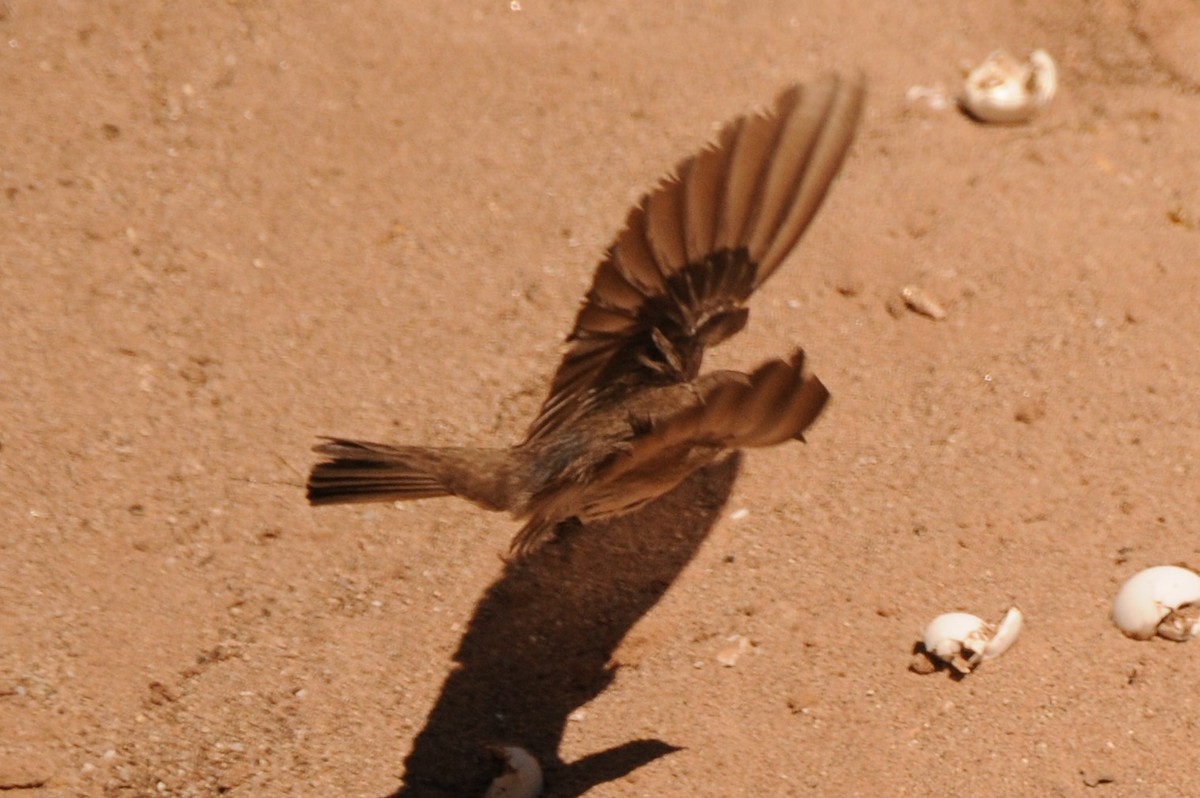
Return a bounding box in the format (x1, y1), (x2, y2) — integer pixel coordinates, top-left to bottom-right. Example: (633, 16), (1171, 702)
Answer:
(308, 77), (864, 556)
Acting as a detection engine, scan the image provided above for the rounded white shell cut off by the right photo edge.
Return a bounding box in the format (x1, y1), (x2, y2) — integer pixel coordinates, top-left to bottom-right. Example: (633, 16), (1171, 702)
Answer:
(1112, 565), (1200, 641)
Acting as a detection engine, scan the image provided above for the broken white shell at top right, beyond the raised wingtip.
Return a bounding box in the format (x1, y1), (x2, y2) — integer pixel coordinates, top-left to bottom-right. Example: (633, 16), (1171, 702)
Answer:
(959, 50), (1058, 124)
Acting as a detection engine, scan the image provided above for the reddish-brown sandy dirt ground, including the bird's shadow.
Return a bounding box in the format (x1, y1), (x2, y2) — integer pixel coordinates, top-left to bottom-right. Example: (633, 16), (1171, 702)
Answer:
(0, 0), (1200, 798)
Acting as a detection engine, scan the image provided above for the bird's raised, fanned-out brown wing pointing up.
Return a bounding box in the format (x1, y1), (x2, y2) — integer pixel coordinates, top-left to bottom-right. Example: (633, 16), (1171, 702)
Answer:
(527, 76), (865, 440)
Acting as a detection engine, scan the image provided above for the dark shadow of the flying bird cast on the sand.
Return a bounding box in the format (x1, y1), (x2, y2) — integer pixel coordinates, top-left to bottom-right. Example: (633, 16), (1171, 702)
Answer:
(389, 454), (740, 798)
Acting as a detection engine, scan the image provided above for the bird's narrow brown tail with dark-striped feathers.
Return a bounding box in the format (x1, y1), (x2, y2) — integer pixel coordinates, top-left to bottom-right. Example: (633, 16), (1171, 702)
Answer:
(308, 438), (511, 510)
